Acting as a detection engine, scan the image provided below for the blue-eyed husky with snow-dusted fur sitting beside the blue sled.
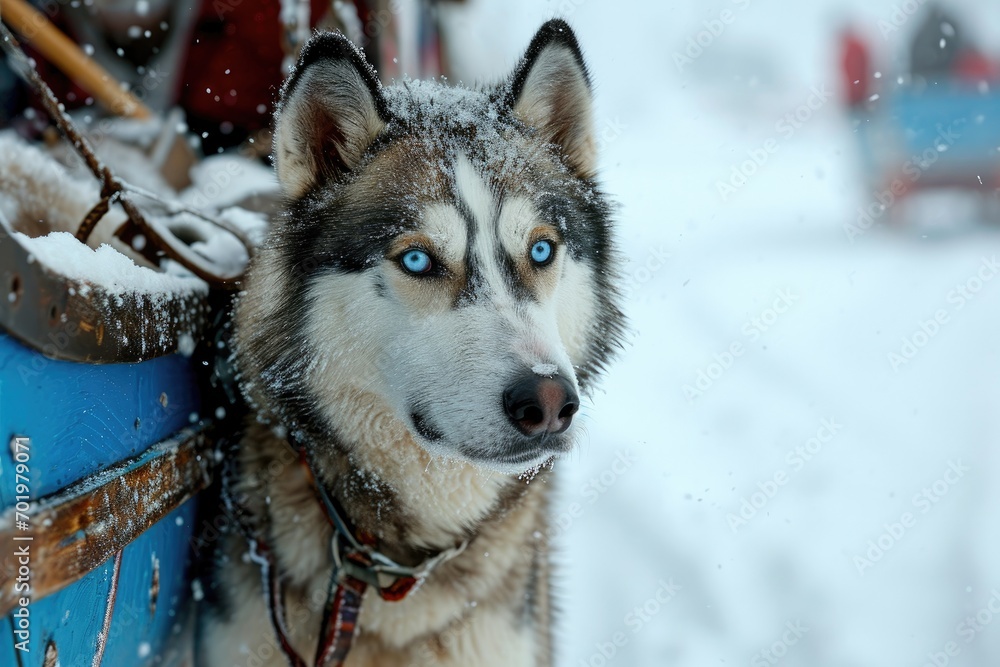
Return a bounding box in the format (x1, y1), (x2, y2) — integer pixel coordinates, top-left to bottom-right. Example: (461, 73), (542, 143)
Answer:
(197, 20), (623, 667)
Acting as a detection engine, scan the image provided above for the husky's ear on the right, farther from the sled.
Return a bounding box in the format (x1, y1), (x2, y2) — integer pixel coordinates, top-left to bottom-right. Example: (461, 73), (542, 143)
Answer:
(507, 19), (597, 178)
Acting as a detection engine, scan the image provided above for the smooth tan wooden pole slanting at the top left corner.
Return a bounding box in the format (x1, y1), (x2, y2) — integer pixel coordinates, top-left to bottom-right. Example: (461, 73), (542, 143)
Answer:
(0, 0), (153, 119)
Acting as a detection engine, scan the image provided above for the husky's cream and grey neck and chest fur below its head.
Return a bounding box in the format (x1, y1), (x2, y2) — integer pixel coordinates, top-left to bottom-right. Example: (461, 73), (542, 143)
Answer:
(196, 408), (551, 667)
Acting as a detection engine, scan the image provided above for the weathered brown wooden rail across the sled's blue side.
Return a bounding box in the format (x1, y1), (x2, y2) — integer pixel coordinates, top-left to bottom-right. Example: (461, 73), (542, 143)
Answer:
(0, 429), (214, 618)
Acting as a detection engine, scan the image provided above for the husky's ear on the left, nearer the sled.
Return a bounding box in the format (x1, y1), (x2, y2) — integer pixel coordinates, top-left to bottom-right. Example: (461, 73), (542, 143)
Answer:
(274, 32), (389, 198)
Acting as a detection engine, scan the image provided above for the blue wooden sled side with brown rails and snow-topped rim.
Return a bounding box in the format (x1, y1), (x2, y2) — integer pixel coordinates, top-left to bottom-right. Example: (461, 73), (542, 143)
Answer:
(0, 147), (210, 665)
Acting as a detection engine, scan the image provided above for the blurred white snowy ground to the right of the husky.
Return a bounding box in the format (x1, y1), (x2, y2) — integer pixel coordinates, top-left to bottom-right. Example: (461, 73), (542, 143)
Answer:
(442, 0), (1000, 667)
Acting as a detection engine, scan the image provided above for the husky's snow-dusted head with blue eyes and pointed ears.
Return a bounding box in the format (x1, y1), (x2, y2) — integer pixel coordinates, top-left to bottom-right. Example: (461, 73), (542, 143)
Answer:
(237, 21), (622, 472)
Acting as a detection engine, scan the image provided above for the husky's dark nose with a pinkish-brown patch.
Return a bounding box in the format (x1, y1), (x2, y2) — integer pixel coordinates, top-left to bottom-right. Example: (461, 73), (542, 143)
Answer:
(503, 375), (580, 435)
